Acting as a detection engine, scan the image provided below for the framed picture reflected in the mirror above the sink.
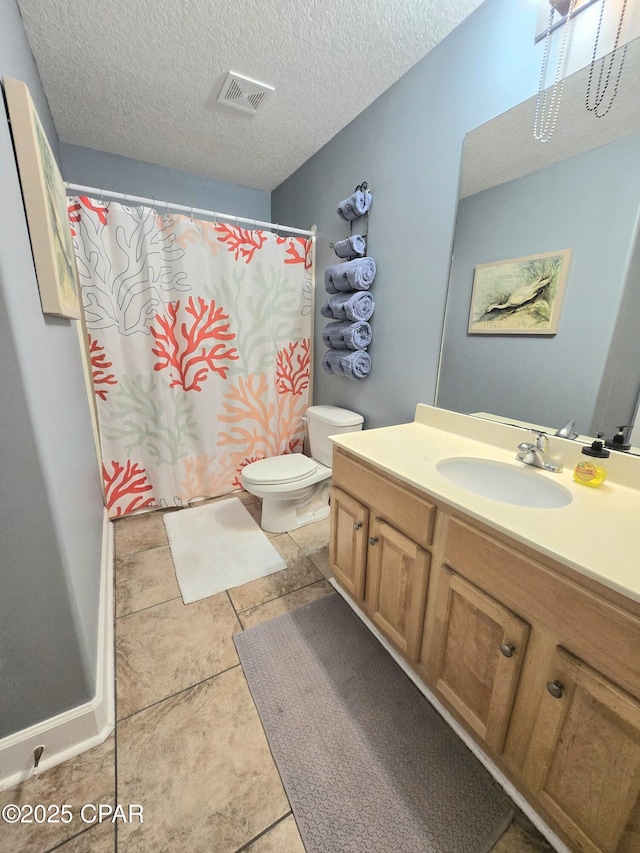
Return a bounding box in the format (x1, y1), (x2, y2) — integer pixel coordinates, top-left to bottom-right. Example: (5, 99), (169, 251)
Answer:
(468, 249), (573, 335)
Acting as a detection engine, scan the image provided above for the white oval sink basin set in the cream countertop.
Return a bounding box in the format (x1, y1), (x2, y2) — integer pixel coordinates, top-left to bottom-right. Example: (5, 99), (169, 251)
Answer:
(436, 456), (573, 509)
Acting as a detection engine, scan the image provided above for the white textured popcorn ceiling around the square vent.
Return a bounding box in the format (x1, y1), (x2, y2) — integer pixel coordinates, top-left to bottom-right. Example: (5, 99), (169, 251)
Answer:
(18, 0), (482, 190)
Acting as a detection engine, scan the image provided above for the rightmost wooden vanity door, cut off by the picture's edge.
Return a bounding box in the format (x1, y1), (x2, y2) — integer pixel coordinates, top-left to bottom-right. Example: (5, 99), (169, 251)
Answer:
(524, 648), (640, 853)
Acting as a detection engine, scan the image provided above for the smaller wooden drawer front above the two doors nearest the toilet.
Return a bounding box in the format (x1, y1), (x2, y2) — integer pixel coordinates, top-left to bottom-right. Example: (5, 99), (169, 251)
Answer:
(332, 450), (435, 547)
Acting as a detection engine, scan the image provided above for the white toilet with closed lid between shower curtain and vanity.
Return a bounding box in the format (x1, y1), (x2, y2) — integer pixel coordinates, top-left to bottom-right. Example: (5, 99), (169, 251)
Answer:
(240, 406), (364, 533)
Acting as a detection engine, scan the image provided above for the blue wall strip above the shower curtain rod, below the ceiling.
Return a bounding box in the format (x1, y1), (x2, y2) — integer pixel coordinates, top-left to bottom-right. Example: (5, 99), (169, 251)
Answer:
(60, 143), (271, 222)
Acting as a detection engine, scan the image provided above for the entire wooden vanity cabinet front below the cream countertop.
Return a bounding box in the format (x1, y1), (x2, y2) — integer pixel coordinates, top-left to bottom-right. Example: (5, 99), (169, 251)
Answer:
(330, 450), (640, 853)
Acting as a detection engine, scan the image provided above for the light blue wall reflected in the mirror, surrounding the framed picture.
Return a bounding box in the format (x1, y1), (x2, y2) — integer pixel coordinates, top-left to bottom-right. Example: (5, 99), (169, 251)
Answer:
(438, 135), (640, 435)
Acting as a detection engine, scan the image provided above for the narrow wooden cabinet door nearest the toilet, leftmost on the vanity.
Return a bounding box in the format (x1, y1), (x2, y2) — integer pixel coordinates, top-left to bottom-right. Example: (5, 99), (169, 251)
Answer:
(329, 487), (369, 602)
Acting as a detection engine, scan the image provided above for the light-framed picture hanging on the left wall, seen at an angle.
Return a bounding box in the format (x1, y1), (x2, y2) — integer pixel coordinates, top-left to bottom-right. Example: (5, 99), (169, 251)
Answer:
(2, 77), (80, 320)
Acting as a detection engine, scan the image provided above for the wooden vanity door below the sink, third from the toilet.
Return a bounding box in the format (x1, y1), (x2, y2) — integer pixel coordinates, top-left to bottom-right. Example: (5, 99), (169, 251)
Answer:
(436, 569), (529, 752)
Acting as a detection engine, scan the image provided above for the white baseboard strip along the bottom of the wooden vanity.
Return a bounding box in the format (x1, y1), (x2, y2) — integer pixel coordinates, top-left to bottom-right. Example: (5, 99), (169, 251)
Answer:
(329, 578), (571, 853)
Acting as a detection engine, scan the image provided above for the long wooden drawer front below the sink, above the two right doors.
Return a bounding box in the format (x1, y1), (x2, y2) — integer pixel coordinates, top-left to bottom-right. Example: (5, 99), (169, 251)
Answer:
(444, 518), (640, 698)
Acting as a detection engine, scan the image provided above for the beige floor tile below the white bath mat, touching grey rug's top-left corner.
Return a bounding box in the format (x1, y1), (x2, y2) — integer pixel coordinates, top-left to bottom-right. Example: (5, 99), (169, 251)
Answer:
(116, 592), (240, 719)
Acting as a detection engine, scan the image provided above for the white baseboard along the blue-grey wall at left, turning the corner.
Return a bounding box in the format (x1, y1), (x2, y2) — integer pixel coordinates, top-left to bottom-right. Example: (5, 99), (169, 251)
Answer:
(0, 510), (115, 791)
